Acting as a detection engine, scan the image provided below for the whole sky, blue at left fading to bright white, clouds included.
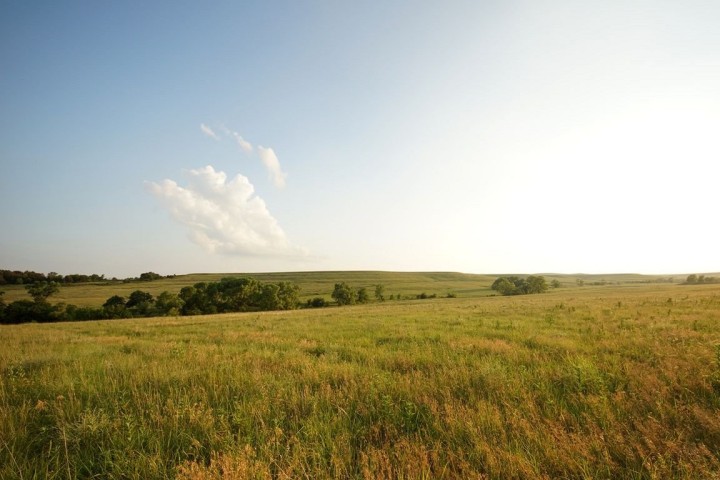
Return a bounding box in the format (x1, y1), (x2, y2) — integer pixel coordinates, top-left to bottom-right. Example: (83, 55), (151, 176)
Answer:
(0, 0), (720, 278)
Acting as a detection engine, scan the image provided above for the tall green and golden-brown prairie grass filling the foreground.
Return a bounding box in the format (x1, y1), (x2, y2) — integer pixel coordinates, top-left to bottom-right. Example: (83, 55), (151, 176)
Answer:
(0, 285), (720, 479)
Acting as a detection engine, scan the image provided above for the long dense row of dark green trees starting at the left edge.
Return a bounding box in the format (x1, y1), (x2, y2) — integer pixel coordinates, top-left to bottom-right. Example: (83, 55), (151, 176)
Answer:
(0, 277), (300, 324)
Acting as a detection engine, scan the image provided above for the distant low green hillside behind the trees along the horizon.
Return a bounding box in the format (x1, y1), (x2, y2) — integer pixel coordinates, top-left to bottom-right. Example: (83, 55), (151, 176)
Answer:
(0, 271), (684, 307)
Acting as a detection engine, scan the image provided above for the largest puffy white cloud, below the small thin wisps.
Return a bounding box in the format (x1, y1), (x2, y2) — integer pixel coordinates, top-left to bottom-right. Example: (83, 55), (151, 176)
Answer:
(147, 165), (306, 256)
